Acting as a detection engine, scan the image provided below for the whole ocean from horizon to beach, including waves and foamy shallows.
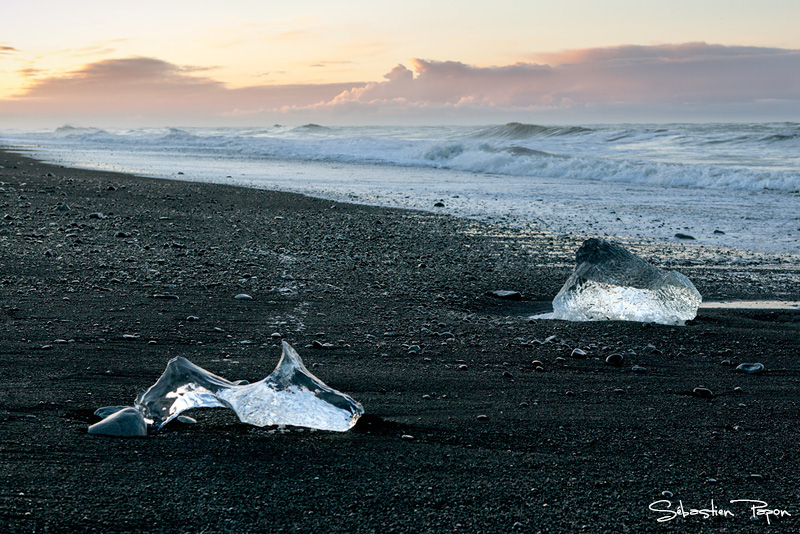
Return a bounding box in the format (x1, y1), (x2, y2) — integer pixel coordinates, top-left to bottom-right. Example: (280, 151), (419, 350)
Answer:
(0, 123), (800, 254)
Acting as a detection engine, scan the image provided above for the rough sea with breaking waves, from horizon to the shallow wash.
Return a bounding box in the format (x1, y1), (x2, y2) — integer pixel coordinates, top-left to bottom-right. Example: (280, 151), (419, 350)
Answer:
(1, 123), (800, 192)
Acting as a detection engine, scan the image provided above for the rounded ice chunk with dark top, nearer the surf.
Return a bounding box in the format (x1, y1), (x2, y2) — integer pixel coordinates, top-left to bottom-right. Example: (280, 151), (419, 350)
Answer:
(552, 238), (702, 325)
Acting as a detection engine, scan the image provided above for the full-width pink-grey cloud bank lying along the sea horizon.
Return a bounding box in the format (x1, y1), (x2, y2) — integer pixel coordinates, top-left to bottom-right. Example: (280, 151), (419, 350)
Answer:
(0, 43), (800, 124)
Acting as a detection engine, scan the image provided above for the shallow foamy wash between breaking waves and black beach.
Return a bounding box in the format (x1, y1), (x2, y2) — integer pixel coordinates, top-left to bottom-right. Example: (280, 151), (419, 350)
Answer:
(3, 140), (800, 263)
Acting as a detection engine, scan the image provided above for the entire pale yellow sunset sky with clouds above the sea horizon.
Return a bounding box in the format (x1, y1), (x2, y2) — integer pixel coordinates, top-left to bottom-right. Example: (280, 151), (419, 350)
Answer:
(0, 0), (800, 128)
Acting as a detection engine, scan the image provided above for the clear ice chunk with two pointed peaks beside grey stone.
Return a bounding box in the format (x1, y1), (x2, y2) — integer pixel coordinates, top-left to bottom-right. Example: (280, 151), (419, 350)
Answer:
(135, 341), (364, 432)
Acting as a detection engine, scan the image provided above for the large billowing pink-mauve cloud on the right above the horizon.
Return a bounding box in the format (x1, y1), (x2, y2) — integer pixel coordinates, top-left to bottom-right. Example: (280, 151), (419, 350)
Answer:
(296, 43), (800, 118)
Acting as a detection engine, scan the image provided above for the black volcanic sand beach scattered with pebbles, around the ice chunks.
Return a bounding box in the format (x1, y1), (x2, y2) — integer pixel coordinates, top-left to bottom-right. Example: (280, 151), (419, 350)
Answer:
(0, 149), (800, 533)
